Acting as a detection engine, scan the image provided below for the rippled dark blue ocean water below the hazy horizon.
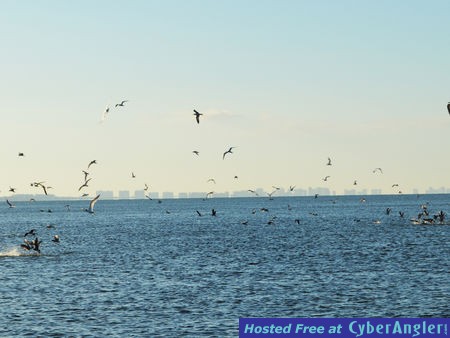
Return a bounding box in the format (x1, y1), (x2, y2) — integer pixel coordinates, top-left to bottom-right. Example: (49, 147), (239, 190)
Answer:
(0, 195), (450, 337)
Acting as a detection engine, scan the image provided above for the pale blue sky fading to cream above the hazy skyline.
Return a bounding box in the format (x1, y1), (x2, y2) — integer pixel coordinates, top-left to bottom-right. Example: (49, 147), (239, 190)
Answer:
(0, 0), (450, 197)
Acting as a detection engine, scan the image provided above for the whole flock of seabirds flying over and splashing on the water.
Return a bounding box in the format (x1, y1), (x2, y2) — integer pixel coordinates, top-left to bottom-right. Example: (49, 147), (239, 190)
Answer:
(6, 100), (450, 254)
